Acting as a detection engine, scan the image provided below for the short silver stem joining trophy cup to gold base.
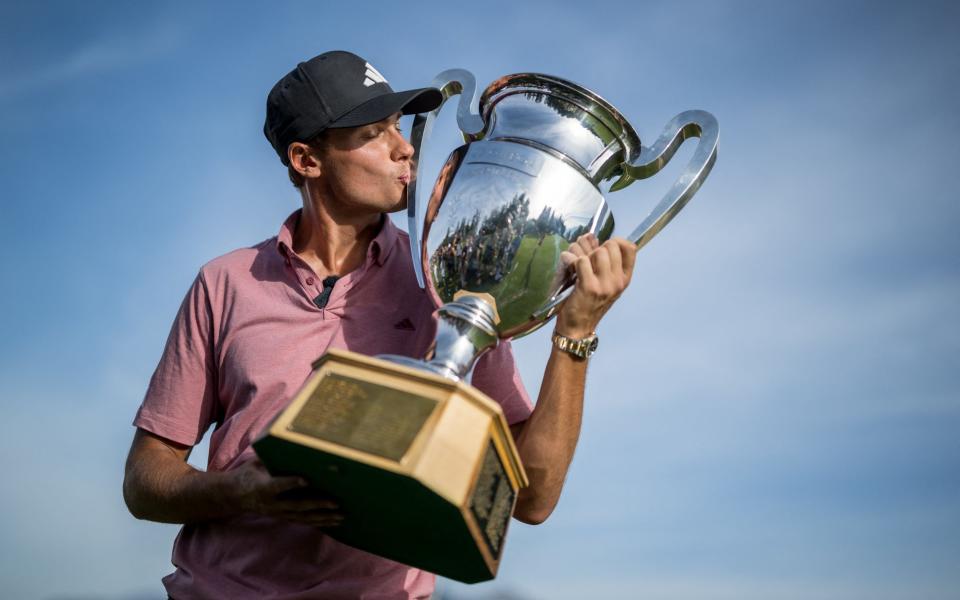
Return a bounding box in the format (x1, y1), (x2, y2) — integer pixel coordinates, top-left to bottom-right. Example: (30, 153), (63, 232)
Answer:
(426, 296), (499, 380)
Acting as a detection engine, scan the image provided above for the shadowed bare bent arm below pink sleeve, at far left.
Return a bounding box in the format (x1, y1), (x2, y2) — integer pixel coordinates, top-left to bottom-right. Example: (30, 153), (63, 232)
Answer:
(123, 434), (238, 523)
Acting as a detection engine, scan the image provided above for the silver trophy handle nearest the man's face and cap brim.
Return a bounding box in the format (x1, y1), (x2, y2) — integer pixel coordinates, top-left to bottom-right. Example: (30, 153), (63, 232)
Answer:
(407, 69), (484, 288)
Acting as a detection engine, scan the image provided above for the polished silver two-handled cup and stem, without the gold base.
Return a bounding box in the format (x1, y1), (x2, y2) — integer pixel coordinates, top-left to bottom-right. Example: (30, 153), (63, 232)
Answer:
(383, 69), (718, 379)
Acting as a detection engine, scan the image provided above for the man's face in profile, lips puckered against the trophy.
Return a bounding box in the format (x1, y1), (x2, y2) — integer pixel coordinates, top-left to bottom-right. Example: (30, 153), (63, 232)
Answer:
(320, 113), (413, 213)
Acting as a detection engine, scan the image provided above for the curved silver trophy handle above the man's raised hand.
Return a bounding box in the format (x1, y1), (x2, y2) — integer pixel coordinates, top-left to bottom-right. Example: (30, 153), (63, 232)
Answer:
(610, 110), (720, 248)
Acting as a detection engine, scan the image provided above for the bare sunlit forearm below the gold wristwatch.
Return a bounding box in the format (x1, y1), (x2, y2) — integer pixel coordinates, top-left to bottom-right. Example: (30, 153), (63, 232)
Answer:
(514, 348), (587, 524)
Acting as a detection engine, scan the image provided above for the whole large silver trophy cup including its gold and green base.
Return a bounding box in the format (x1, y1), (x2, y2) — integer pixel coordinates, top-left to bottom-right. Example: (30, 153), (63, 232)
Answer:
(254, 70), (717, 582)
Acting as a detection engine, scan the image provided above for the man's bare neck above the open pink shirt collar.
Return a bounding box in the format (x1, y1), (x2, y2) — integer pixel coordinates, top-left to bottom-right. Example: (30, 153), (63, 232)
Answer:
(293, 185), (384, 278)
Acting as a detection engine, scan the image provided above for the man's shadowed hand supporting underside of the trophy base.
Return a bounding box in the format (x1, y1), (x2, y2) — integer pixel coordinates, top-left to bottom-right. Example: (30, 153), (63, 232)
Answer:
(223, 458), (343, 527)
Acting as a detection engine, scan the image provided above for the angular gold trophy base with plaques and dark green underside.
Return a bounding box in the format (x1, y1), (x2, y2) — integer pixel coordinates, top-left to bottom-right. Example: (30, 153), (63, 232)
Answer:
(253, 350), (527, 583)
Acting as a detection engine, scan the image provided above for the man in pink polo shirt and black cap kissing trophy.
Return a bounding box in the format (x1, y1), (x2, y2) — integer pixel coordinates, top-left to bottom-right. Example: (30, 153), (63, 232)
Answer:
(124, 52), (636, 598)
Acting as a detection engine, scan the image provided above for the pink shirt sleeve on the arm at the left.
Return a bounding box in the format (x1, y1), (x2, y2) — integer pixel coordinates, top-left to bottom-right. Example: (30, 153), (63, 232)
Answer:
(133, 271), (217, 446)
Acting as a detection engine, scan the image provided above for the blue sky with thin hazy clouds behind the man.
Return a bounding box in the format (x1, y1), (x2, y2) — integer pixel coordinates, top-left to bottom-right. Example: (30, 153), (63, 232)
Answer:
(0, 1), (960, 600)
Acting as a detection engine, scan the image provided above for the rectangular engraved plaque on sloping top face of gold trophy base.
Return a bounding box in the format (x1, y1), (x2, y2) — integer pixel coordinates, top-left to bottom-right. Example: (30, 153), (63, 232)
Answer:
(290, 373), (437, 461)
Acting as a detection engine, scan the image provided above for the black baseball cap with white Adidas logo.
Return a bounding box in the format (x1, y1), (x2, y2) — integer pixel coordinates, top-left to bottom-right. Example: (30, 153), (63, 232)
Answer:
(263, 50), (443, 165)
